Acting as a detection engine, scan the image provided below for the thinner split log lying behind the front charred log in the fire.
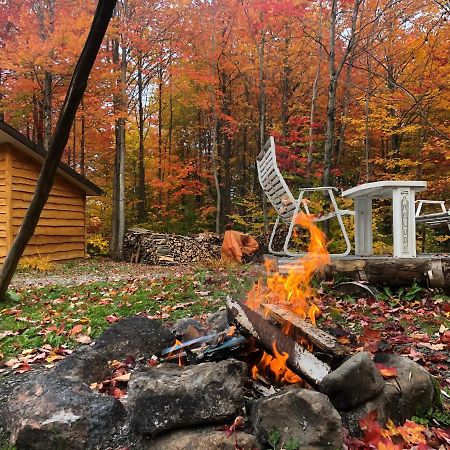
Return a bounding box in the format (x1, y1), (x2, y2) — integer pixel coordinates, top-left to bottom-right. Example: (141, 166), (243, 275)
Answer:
(263, 304), (351, 356)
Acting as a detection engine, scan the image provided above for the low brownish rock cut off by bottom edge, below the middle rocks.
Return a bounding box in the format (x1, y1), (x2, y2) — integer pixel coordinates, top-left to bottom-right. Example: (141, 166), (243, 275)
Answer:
(144, 427), (258, 450)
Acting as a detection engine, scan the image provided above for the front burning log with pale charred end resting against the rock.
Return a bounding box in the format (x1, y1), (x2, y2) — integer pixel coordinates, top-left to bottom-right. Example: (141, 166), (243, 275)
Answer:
(227, 298), (331, 386)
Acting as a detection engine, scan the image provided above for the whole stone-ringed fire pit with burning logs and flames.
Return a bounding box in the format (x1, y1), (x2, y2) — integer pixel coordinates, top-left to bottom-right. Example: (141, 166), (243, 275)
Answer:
(8, 216), (433, 450)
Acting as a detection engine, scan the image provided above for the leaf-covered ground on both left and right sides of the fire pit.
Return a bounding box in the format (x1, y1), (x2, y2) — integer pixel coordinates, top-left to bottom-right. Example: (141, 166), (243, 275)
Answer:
(0, 258), (450, 448)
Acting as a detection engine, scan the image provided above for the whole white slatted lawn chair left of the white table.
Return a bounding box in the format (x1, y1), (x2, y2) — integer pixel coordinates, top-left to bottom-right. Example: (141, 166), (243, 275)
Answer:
(256, 136), (354, 257)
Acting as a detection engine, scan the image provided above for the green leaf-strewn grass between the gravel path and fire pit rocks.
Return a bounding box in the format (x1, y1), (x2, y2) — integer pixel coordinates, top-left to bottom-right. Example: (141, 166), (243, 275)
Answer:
(0, 267), (252, 359)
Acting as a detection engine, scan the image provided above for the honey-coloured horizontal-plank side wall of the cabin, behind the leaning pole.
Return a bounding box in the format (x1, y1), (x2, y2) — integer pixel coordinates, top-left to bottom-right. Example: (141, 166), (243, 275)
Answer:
(0, 144), (86, 261)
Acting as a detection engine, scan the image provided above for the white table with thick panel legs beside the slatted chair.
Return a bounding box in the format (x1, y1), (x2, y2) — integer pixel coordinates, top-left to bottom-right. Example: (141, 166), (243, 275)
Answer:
(342, 181), (427, 258)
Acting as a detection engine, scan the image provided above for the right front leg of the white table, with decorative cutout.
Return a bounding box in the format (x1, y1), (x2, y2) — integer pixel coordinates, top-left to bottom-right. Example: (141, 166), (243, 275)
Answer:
(392, 188), (416, 258)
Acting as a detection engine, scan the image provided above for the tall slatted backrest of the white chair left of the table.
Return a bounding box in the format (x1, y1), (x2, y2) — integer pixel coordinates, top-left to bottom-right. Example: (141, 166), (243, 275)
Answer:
(256, 136), (295, 224)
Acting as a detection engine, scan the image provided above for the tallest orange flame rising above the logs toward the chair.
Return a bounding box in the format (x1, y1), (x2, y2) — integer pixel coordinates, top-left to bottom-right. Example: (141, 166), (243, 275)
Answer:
(247, 212), (330, 324)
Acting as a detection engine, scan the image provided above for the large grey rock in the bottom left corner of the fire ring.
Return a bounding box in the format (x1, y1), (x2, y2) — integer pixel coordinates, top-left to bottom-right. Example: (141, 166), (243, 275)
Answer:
(8, 373), (126, 450)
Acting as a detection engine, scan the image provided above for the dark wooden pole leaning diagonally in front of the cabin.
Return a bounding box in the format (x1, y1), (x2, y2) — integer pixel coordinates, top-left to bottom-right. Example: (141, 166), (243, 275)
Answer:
(0, 0), (116, 301)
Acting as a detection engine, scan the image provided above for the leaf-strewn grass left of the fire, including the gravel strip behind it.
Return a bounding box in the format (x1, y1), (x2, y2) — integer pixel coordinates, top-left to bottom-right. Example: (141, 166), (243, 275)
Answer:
(0, 259), (259, 370)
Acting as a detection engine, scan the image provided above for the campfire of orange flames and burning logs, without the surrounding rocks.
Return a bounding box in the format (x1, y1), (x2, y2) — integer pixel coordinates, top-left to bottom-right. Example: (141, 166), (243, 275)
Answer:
(155, 213), (342, 386)
